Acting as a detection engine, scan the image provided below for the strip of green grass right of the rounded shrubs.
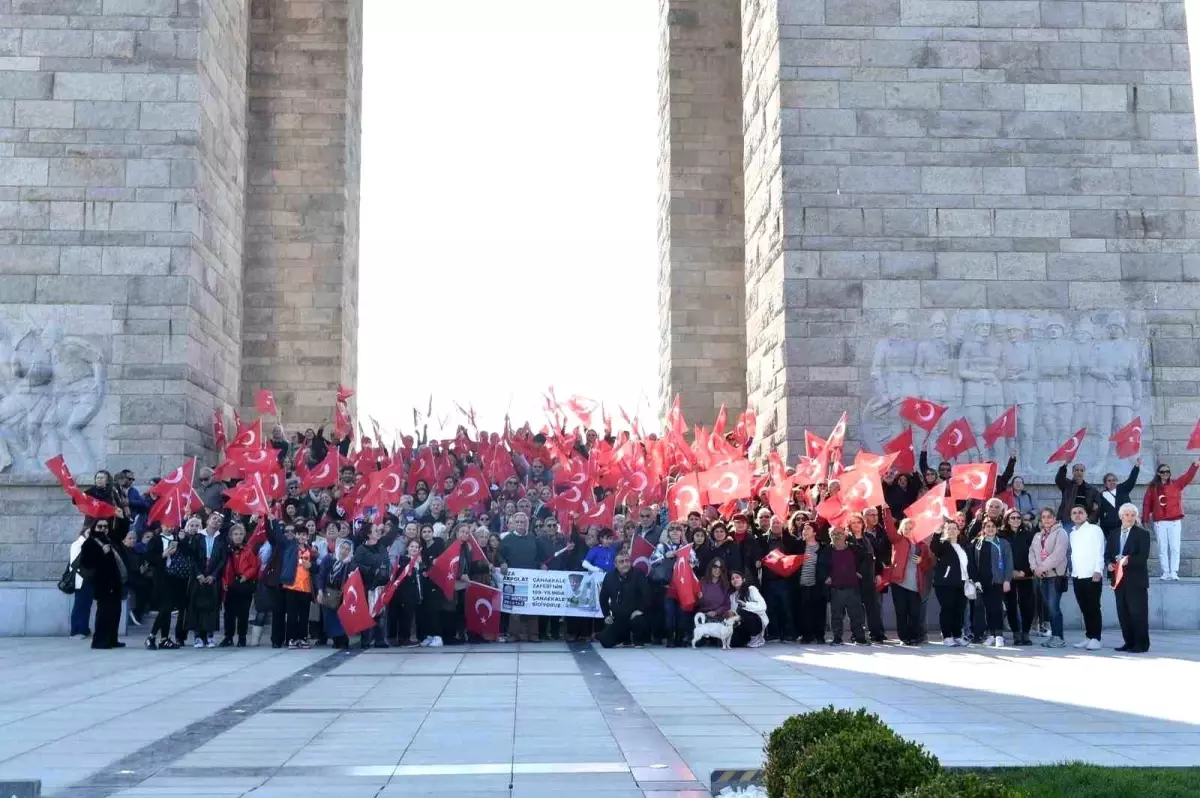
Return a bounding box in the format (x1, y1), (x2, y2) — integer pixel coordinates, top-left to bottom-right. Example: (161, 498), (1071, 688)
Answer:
(971, 762), (1200, 798)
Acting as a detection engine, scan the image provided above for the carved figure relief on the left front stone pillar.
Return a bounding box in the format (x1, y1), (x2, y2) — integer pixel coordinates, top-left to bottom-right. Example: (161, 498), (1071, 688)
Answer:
(0, 323), (108, 474)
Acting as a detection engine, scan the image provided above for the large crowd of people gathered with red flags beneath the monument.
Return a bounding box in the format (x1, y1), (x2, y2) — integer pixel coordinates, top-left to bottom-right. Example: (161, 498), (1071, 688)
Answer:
(64, 410), (1200, 653)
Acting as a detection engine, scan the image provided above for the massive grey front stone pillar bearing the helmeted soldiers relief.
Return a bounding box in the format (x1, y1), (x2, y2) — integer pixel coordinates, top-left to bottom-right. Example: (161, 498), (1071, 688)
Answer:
(742, 0), (1200, 572)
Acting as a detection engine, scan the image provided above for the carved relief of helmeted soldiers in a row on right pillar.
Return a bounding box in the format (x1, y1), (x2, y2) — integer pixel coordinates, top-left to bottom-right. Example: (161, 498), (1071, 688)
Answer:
(862, 310), (1152, 482)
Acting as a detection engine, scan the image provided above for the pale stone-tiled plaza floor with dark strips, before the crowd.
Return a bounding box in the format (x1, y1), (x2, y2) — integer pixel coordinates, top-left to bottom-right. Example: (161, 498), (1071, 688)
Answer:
(0, 632), (1200, 798)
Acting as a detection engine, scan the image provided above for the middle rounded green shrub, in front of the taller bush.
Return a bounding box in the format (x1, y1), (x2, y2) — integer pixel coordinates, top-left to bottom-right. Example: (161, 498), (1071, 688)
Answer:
(784, 727), (942, 798)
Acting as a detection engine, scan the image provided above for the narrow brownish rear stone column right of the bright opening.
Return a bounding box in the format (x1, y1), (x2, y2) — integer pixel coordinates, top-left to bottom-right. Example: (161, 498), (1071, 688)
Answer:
(659, 0), (745, 425)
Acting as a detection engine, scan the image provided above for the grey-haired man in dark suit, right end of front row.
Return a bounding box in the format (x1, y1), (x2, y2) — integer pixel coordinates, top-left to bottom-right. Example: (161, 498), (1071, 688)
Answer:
(1104, 503), (1150, 654)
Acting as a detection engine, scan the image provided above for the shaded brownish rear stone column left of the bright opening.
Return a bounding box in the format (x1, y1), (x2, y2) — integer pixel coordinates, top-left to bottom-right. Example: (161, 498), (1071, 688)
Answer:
(241, 0), (362, 426)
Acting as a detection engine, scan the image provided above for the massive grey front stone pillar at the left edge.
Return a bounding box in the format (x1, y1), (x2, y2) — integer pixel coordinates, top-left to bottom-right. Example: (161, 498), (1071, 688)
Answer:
(0, 0), (247, 583)
